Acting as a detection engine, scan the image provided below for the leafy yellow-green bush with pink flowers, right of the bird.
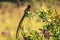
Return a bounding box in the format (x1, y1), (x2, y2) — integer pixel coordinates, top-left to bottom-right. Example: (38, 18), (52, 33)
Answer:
(17, 9), (60, 40)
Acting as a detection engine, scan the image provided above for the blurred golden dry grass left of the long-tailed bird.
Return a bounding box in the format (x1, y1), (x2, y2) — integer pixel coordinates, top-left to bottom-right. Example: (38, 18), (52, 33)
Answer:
(0, 2), (26, 40)
